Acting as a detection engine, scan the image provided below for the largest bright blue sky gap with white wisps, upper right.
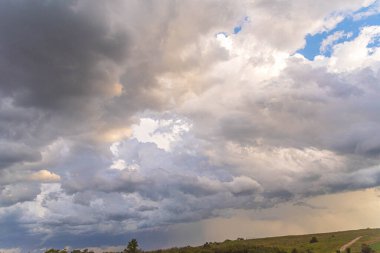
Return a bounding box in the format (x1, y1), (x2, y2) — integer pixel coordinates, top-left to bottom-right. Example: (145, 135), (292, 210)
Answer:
(297, 1), (380, 60)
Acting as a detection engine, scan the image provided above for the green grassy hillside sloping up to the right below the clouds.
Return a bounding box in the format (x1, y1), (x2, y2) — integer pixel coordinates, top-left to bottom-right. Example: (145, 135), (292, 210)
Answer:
(149, 229), (380, 253)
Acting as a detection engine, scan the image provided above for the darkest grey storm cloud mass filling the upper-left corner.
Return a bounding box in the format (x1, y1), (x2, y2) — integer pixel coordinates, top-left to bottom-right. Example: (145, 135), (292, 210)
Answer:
(0, 1), (128, 110)
